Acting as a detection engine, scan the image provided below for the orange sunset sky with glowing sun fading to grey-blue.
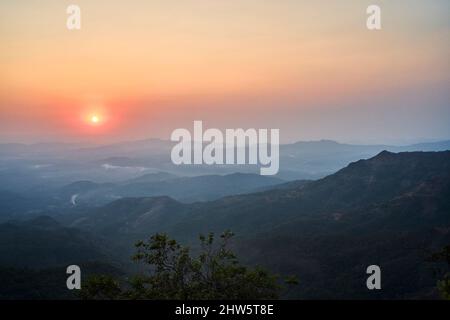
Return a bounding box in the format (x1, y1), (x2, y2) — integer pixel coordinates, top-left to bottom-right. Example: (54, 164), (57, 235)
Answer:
(0, 0), (450, 144)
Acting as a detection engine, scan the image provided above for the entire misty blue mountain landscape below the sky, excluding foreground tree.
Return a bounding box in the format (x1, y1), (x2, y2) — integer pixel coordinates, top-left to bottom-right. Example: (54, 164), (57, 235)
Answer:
(0, 139), (450, 299)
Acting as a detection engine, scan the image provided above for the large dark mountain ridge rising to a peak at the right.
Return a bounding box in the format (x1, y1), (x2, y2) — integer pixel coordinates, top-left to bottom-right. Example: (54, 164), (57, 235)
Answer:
(73, 151), (450, 299)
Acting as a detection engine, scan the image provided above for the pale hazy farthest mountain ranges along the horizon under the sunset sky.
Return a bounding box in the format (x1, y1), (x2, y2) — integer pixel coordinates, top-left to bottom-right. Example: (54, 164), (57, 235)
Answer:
(0, 139), (450, 185)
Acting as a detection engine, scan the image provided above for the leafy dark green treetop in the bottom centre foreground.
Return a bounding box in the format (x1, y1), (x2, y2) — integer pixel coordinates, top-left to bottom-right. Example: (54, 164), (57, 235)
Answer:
(82, 232), (296, 300)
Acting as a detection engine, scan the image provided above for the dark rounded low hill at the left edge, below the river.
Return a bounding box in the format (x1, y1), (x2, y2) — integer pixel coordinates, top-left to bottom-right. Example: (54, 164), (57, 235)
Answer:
(0, 216), (119, 269)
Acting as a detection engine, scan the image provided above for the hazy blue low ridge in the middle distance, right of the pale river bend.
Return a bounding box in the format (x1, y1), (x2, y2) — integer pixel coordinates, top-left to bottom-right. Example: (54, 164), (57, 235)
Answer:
(57, 172), (283, 205)
